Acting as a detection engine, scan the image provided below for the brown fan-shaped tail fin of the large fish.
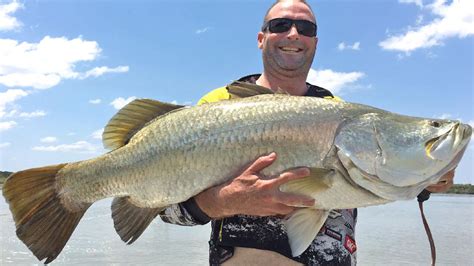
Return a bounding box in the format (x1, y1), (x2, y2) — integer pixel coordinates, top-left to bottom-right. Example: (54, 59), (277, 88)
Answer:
(3, 164), (90, 264)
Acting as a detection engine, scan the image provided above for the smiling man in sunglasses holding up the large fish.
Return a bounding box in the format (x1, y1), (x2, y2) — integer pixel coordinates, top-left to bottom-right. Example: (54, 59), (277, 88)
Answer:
(161, 0), (453, 265)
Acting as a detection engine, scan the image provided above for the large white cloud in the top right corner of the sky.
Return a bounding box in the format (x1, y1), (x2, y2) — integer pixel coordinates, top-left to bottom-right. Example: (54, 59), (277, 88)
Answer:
(379, 0), (474, 54)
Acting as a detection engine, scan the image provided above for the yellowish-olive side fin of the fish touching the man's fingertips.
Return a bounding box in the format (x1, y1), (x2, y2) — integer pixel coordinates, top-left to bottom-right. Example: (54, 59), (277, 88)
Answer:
(280, 168), (335, 196)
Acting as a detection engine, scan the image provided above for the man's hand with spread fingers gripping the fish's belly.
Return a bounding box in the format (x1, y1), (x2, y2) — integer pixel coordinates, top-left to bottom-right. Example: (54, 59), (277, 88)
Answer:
(194, 153), (314, 219)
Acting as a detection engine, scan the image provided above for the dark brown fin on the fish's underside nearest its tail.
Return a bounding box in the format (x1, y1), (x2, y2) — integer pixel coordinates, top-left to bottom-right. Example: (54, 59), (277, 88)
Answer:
(112, 197), (163, 245)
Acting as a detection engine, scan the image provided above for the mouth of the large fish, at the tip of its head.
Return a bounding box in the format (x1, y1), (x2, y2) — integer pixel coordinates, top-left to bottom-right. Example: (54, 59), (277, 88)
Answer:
(425, 123), (472, 160)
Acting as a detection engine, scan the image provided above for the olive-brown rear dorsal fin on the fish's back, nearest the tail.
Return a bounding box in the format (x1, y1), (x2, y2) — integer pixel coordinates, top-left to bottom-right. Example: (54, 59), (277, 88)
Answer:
(102, 99), (184, 149)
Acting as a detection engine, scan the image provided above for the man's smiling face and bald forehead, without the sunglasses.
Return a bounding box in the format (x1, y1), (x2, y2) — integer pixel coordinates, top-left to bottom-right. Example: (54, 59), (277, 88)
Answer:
(258, 1), (318, 77)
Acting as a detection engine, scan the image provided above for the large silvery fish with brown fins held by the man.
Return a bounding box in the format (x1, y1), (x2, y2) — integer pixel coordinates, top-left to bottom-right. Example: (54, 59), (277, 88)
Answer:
(3, 86), (472, 263)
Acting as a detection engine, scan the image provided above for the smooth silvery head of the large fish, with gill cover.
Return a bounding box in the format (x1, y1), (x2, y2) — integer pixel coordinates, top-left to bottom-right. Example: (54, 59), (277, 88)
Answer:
(335, 112), (472, 187)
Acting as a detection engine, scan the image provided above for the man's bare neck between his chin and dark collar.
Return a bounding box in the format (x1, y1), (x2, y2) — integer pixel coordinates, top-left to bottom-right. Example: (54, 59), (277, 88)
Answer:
(256, 72), (308, 96)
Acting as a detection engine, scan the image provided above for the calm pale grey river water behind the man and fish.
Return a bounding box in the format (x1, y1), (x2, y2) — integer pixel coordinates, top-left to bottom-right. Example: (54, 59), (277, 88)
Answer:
(0, 195), (474, 265)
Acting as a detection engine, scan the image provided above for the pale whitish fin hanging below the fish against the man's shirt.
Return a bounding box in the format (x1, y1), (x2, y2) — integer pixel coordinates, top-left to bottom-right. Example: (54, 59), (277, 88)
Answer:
(284, 208), (330, 257)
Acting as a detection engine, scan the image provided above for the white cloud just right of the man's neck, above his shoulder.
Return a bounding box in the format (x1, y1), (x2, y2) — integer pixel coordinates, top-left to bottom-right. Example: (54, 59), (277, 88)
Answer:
(307, 69), (365, 94)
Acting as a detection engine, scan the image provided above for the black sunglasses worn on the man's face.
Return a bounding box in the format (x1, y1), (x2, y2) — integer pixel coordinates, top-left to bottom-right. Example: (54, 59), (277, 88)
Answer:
(262, 18), (318, 37)
